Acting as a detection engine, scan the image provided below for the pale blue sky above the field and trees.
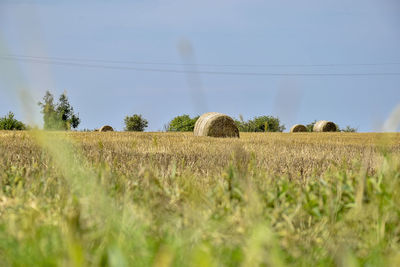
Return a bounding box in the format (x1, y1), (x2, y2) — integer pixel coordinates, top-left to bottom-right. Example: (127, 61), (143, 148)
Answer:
(0, 0), (400, 132)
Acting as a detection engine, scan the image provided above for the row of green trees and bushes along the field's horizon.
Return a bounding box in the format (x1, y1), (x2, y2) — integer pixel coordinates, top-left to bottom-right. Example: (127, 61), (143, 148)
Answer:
(0, 91), (357, 132)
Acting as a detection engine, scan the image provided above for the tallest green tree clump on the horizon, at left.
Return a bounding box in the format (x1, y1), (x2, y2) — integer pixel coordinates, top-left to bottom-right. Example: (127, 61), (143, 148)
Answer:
(38, 91), (81, 130)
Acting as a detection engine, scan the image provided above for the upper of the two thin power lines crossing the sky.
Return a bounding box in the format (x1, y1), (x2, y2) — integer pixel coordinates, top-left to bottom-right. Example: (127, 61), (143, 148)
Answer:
(0, 54), (400, 67)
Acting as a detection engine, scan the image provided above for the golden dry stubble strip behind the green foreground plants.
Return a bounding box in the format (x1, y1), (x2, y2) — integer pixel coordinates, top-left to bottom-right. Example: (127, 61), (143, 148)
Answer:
(1, 132), (400, 179)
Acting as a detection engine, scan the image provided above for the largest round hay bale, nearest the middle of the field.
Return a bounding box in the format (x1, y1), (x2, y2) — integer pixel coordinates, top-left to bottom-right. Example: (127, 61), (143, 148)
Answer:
(194, 112), (239, 137)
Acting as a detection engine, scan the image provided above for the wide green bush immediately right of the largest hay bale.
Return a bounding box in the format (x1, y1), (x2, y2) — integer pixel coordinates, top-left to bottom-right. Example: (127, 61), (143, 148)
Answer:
(235, 116), (286, 132)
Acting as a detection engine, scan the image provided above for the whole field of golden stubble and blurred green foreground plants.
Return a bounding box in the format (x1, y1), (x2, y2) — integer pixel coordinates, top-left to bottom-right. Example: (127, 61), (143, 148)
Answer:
(0, 132), (400, 266)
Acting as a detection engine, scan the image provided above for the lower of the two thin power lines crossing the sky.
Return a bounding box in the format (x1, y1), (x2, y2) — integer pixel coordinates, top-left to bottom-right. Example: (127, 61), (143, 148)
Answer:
(0, 56), (400, 77)
